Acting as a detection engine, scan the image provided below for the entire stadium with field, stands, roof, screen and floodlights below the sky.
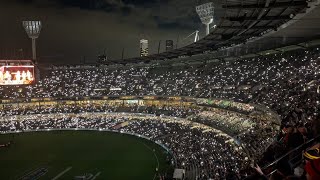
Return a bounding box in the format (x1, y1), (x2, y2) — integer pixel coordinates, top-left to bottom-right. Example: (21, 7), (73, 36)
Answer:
(0, 0), (320, 180)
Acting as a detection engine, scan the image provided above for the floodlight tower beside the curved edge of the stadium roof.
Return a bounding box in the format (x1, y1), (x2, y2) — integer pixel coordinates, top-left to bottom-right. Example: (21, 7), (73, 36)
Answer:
(196, 2), (214, 35)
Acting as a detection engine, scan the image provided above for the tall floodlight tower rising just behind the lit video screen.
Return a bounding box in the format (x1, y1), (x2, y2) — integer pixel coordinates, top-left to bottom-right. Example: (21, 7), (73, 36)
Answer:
(22, 21), (42, 61)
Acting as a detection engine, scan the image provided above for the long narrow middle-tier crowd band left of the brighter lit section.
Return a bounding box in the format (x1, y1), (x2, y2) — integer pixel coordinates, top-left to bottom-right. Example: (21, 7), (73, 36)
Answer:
(0, 103), (201, 118)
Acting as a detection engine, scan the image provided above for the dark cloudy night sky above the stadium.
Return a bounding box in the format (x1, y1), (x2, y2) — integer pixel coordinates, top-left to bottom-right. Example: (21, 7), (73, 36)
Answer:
(0, 0), (218, 62)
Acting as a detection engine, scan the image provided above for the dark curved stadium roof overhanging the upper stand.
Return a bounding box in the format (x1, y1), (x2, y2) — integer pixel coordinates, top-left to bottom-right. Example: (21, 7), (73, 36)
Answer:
(110, 0), (320, 64)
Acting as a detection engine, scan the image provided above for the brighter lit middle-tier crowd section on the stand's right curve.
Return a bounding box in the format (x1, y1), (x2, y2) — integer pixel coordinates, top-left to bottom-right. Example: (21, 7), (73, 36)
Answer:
(190, 108), (279, 162)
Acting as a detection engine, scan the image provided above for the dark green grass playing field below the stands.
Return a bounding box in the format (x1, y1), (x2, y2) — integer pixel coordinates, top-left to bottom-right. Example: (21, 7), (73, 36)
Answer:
(0, 131), (170, 180)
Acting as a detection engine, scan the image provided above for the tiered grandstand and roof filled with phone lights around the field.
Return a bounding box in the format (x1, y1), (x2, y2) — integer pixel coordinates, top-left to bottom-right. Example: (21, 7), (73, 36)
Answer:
(0, 0), (320, 179)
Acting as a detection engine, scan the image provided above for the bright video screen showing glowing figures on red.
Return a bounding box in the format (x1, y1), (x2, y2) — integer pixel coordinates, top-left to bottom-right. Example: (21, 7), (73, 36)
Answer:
(0, 66), (34, 85)
